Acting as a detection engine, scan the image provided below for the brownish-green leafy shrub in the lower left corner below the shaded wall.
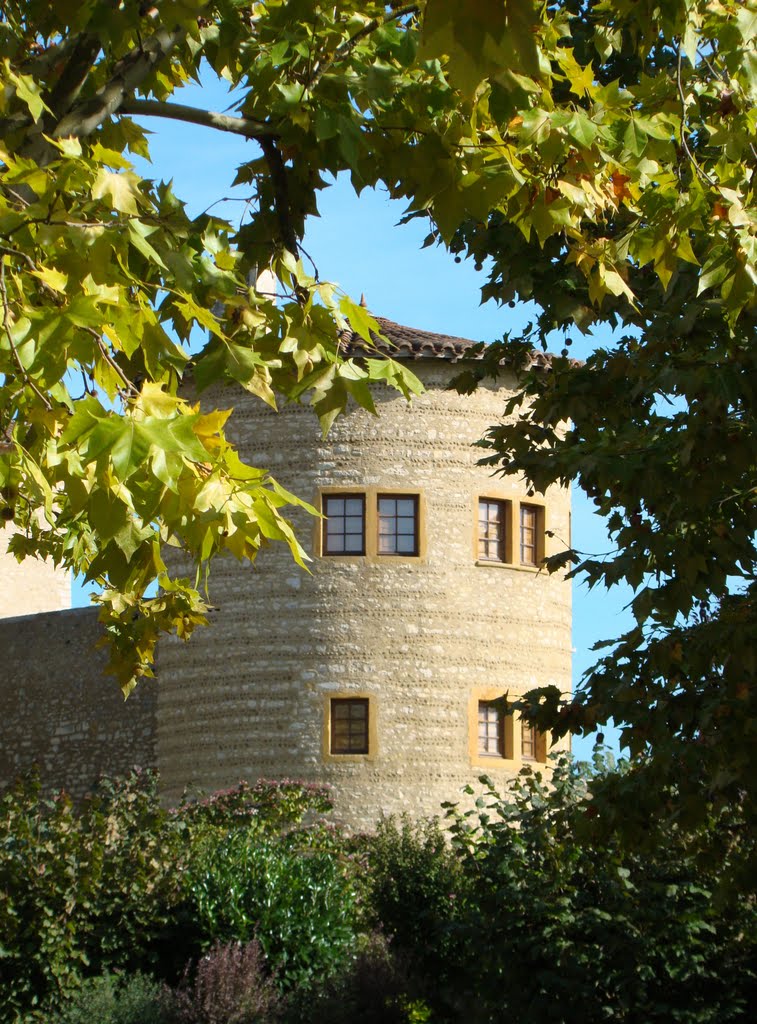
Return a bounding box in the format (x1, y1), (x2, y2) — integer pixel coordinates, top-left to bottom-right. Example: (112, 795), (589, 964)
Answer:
(0, 773), (181, 1022)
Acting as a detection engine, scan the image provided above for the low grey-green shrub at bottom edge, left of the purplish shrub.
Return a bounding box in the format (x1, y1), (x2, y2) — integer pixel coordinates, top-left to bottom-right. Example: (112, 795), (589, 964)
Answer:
(50, 974), (169, 1024)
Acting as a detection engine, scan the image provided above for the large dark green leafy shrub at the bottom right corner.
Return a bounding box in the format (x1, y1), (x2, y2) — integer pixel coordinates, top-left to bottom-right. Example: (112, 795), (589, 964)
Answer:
(440, 761), (757, 1024)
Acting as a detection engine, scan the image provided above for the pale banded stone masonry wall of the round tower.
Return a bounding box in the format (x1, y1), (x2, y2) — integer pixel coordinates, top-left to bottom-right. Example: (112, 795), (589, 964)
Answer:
(158, 359), (571, 827)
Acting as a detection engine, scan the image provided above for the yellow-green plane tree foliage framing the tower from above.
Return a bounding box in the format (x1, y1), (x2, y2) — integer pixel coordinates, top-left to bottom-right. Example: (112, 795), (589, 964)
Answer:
(0, 0), (757, 856)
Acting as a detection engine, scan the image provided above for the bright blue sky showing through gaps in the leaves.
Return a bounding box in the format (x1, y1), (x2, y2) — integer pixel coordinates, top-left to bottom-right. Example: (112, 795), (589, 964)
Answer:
(74, 74), (630, 757)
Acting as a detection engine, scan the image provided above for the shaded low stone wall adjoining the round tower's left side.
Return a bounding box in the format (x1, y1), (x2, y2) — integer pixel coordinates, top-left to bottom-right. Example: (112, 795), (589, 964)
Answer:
(0, 608), (156, 798)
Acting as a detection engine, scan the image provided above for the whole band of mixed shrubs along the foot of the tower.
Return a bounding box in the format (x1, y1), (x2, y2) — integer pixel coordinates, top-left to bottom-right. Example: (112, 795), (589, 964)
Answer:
(0, 760), (757, 1024)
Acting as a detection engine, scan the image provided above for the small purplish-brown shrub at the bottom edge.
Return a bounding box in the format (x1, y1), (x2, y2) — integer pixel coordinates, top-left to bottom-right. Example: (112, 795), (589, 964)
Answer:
(166, 939), (282, 1024)
